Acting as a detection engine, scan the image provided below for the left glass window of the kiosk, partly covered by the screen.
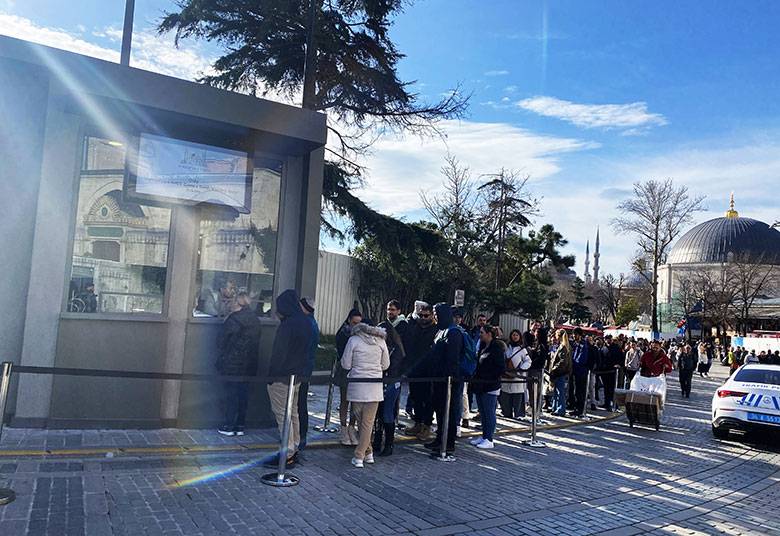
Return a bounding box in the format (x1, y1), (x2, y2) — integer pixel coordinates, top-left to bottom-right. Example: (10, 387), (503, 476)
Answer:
(67, 136), (171, 314)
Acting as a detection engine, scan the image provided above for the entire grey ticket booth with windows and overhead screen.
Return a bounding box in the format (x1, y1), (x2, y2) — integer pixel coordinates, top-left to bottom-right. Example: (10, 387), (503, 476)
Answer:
(0, 37), (326, 427)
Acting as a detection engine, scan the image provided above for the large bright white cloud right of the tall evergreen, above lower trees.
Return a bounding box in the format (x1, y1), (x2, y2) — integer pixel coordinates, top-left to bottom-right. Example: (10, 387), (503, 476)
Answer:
(359, 121), (598, 215)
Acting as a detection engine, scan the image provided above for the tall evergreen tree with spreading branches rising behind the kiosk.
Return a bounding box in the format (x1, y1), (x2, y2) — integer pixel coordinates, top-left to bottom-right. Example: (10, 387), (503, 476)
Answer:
(158, 0), (468, 250)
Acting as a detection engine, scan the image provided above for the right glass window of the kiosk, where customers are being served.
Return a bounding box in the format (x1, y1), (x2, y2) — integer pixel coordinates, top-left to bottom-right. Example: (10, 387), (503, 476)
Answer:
(193, 159), (282, 317)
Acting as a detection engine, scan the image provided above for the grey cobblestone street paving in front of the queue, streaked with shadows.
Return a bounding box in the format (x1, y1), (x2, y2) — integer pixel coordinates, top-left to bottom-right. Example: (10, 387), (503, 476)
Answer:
(0, 367), (780, 536)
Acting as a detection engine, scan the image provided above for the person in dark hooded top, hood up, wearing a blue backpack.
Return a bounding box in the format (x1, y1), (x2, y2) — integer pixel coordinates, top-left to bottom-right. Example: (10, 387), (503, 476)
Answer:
(425, 303), (464, 455)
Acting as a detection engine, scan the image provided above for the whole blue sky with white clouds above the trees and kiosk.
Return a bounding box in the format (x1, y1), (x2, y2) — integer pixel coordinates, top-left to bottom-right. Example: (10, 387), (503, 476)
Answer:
(0, 0), (780, 273)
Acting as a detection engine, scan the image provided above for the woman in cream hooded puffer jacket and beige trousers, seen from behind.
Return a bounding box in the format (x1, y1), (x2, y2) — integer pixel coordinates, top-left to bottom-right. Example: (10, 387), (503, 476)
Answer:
(341, 323), (390, 468)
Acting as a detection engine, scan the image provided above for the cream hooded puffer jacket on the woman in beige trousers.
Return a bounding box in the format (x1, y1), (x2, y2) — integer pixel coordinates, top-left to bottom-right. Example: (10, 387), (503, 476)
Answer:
(341, 323), (390, 402)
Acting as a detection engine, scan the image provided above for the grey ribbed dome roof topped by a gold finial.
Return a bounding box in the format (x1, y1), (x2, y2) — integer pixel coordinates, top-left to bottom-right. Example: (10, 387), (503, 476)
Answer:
(667, 217), (780, 264)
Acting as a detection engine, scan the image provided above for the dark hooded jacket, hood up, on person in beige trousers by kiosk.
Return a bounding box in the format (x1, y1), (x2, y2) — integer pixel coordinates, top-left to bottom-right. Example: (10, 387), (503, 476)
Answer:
(268, 289), (313, 380)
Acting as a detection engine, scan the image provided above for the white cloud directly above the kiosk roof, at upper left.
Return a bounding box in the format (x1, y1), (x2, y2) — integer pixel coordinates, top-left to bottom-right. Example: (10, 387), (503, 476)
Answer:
(0, 13), (212, 80)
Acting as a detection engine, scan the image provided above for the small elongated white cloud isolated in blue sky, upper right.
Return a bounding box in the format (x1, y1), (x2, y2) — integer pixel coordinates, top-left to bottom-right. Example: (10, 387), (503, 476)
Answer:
(517, 96), (667, 134)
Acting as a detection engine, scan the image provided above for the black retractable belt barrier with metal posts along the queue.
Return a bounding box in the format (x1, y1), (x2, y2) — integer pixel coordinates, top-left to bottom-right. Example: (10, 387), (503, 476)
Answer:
(0, 361), (546, 492)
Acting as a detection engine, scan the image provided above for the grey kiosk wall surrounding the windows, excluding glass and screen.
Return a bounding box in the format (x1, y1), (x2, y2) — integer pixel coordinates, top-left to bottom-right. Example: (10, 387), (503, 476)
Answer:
(0, 37), (327, 427)
